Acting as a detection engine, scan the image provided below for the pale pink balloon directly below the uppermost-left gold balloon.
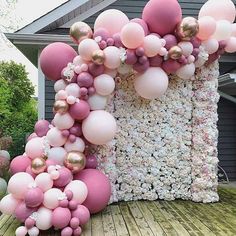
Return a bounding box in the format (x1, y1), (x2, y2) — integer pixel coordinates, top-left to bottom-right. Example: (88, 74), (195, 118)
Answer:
(79, 39), (100, 61)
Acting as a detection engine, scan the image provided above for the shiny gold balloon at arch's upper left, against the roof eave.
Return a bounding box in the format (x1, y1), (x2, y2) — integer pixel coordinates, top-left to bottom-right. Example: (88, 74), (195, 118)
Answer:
(70, 21), (93, 44)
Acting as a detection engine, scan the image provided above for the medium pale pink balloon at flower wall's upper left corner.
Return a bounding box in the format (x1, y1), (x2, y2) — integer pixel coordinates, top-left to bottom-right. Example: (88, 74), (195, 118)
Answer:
(94, 74), (115, 96)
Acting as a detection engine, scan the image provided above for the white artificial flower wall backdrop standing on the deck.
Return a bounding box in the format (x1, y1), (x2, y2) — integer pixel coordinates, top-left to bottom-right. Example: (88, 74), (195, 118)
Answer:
(91, 63), (219, 202)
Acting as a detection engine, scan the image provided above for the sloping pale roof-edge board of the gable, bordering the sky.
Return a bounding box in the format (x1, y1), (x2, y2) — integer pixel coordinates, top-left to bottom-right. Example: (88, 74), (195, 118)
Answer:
(17, 0), (90, 34)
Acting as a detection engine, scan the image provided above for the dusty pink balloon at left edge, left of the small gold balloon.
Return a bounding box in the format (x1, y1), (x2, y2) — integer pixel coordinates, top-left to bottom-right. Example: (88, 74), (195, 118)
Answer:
(10, 156), (31, 175)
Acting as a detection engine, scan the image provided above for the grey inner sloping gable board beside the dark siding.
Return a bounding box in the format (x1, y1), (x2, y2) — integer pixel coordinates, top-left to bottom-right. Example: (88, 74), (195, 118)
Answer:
(60, 0), (117, 28)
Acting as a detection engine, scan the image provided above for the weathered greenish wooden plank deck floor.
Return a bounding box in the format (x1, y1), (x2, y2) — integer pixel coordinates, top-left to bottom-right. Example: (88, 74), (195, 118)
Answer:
(0, 188), (236, 236)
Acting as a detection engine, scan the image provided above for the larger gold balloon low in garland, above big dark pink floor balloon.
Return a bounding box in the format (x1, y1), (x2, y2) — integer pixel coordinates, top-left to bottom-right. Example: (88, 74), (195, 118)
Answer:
(64, 151), (86, 173)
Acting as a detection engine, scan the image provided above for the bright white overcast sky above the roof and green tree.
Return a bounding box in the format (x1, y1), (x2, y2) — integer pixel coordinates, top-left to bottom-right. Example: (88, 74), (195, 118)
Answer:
(0, 0), (67, 96)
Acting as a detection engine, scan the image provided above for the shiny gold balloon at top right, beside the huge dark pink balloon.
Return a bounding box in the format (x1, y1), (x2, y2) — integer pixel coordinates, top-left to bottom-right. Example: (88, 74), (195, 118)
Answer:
(176, 17), (199, 41)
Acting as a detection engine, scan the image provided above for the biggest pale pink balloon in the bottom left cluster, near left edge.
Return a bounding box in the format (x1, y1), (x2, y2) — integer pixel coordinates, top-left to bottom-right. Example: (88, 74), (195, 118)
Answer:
(7, 172), (34, 199)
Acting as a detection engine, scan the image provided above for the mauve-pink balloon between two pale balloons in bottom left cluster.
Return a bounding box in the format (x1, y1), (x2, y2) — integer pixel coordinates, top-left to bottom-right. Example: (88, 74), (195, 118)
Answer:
(24, 188), (43, 207)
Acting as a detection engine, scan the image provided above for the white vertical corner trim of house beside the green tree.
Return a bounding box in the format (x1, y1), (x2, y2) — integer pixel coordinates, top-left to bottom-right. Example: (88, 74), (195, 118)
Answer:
(38, 50), (45, 120)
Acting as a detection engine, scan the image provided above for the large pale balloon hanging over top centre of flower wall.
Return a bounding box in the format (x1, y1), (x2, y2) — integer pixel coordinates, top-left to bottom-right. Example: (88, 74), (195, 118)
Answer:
(134, 67), (169, 99)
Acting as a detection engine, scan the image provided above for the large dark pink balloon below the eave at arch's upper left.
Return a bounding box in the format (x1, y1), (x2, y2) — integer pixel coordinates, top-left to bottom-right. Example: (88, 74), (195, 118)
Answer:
(39, 42), (77, 80)
